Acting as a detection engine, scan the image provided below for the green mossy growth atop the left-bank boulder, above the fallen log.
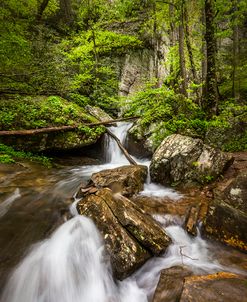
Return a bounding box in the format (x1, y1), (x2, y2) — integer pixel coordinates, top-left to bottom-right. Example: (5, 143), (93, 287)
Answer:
(0, 96), (100, 130)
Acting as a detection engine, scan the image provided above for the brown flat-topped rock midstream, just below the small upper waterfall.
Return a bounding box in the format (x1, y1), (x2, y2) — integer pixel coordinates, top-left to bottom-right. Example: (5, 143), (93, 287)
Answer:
(90, 165), (148, 196)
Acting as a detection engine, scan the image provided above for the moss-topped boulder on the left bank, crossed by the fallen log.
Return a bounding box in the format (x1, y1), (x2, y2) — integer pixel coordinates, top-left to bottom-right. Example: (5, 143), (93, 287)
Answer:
(0, 96), (105, 152)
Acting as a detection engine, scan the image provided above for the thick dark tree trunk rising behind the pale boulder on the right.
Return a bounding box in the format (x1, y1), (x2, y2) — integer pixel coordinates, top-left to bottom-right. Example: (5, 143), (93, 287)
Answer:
(203, 0), (219, 118)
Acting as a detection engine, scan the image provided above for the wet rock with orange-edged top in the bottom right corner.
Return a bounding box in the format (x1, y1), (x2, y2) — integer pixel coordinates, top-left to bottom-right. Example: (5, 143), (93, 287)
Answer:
(179, 272), (247, 302)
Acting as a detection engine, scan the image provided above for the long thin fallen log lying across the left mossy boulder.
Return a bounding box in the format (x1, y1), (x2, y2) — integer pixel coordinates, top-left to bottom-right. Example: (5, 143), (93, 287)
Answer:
(0, 116), (139, 136)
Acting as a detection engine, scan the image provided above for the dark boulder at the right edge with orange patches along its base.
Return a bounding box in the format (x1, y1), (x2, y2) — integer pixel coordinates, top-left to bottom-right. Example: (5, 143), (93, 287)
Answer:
(204, 171), (247, 251)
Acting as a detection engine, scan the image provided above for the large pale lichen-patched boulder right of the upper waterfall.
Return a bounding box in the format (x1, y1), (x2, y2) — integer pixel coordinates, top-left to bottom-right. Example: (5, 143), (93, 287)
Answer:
(150, 134), (233, 185)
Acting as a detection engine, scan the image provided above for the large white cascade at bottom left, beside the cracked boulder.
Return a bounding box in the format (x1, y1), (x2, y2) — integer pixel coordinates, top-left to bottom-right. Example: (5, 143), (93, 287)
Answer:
(1, 215), (145, 302)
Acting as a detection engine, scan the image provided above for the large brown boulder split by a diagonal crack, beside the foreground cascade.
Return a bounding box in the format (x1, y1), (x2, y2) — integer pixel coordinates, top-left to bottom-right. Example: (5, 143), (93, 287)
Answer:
(77, 188), (170, 279)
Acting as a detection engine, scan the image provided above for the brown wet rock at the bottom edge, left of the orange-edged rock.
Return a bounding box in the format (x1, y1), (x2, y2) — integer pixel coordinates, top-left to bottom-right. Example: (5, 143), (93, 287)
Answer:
(153, 266), (192, 302)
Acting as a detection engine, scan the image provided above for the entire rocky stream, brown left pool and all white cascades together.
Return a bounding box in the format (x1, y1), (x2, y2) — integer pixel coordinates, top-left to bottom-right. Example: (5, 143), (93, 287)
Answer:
(0, 123), (247, 302)
